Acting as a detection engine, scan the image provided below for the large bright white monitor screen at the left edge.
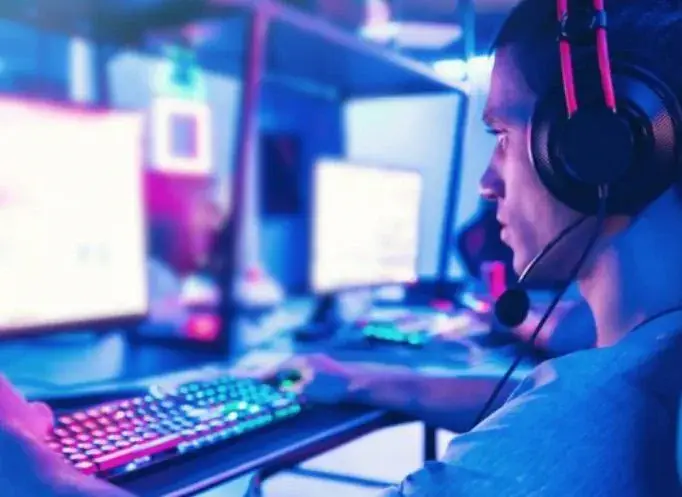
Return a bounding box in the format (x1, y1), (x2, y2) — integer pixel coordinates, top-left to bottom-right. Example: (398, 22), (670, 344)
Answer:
(0, 98), (148, 332)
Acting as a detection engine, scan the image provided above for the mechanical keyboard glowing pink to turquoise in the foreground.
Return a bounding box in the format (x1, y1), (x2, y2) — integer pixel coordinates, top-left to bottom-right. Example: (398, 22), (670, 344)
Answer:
(47, 376), (305, 478)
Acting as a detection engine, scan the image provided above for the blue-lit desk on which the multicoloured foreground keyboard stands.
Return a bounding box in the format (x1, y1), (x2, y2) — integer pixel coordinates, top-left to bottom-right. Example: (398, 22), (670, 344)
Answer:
(0, 328), (525, 497)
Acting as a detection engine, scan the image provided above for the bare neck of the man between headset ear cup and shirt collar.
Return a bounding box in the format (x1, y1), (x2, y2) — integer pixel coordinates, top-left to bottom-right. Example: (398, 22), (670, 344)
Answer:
(579, 192), (682, 347)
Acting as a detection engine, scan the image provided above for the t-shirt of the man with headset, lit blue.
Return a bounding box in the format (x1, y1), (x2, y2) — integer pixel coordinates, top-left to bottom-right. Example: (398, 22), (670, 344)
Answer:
(382, 321), (682, 497)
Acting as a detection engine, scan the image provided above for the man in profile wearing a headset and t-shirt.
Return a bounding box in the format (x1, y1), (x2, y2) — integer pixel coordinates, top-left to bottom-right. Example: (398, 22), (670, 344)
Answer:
(0, 0), (682, 497)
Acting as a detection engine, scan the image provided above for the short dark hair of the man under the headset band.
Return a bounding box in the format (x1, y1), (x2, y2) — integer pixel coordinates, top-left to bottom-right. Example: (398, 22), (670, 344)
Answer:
(492, 0), (682, 98)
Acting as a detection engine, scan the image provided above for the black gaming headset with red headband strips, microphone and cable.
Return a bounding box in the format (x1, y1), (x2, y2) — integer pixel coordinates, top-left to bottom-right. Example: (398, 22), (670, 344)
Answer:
(476, 0), (682, 424)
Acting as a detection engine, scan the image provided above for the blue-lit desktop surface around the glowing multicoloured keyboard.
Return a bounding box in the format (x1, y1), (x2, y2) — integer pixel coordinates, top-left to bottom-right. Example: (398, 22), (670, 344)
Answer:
(0, 296), (527, 496)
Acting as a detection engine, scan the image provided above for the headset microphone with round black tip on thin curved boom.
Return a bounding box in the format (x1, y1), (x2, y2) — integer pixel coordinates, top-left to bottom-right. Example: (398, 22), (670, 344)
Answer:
(495, 216), (589, 328)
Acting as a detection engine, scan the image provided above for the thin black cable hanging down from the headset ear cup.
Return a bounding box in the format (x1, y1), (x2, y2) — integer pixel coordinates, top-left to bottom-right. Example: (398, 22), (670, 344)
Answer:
(473, 186), (608, 427)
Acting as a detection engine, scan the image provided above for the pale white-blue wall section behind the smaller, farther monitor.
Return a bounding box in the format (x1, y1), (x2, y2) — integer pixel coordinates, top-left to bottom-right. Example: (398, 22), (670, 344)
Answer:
(344, 95), (461, 278)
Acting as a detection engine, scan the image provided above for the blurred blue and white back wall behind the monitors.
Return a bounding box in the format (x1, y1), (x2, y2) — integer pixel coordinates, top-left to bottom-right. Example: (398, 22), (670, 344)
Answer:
(110, 53), (484, 290)
